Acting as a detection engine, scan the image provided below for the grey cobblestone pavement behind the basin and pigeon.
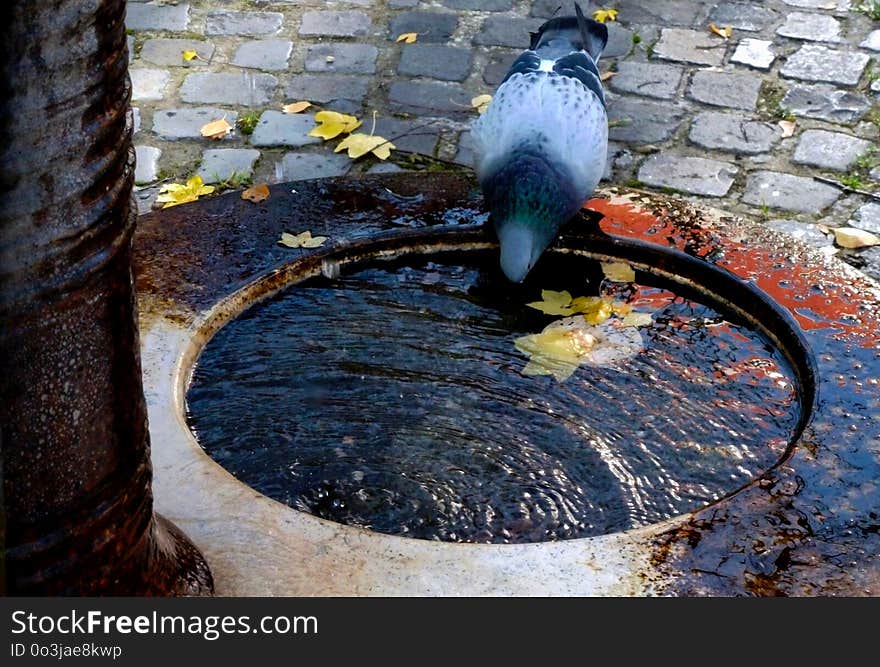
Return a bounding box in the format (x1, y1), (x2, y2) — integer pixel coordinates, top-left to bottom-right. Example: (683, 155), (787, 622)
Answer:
(127, 0), (880, 278)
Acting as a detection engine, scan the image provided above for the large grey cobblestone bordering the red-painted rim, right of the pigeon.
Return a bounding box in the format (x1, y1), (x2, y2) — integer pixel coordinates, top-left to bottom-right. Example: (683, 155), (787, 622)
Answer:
(638, 153), (739, 197)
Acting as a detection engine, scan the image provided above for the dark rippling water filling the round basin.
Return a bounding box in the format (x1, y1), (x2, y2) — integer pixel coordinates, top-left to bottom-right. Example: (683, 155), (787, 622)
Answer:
(187, 256), (800, 542)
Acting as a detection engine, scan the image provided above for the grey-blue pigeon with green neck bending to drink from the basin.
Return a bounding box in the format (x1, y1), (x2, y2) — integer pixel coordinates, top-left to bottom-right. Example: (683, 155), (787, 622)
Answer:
(471, 3), (608, 283)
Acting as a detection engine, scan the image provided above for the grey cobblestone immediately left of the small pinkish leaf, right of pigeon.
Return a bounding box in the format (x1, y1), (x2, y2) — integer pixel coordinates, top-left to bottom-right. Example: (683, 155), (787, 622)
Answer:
(688, 111), (781, 155)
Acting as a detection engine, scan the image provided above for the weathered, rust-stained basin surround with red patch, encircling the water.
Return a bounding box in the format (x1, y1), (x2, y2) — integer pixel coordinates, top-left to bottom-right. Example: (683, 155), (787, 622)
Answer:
(134, 174), (880, 596)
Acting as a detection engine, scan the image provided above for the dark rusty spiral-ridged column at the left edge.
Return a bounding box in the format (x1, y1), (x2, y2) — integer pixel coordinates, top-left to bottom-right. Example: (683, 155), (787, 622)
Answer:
(0, 0), (213, 595)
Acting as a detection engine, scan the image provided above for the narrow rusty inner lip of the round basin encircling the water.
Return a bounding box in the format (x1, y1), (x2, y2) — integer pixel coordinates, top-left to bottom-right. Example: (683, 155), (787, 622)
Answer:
(184, 225), (816, 546)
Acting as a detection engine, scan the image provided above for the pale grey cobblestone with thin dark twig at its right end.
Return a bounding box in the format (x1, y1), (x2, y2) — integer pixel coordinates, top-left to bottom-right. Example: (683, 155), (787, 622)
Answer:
(742, 171), (840, 213)
